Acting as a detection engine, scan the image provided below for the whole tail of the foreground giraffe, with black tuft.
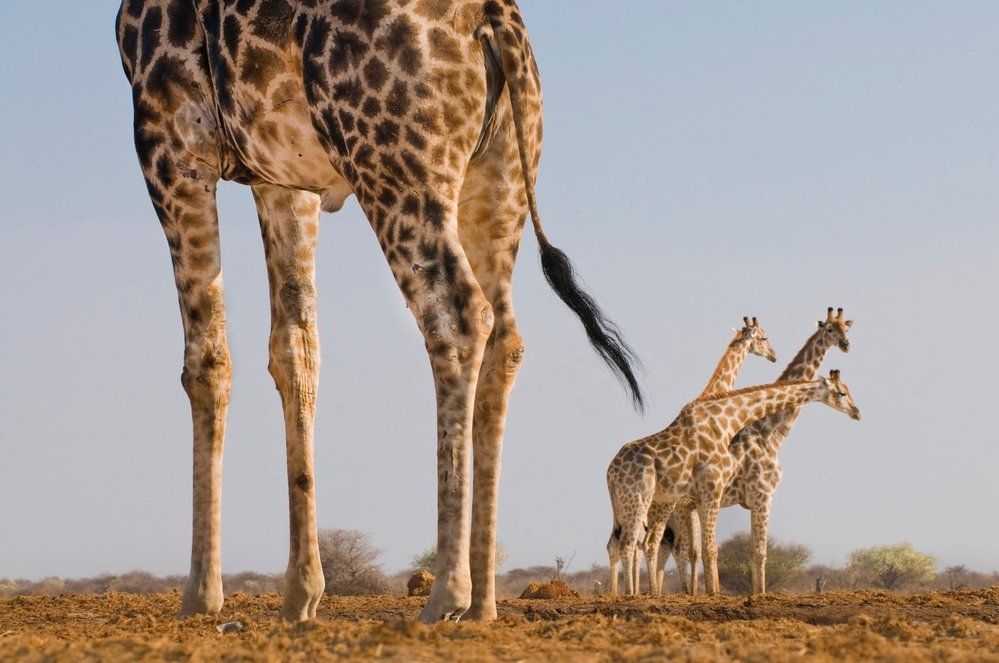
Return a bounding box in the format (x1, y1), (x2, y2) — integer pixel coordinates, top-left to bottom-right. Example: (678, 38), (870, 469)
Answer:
(477, 0), (645, 412)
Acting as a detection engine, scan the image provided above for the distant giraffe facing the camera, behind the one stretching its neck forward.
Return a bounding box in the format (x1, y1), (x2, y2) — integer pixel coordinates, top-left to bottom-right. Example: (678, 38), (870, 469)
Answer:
(664, 306), (853, 594)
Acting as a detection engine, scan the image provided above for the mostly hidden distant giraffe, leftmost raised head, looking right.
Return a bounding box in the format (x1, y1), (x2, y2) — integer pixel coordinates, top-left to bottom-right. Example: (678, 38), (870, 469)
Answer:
(607, 317), (777, 594)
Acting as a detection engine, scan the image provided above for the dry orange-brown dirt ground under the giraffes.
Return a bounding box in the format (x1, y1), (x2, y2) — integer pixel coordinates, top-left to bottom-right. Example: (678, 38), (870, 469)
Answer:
(0, 587), (999, 661)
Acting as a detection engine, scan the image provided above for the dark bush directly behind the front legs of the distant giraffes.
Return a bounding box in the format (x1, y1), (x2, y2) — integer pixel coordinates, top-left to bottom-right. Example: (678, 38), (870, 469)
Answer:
(718, 532), (812, 594)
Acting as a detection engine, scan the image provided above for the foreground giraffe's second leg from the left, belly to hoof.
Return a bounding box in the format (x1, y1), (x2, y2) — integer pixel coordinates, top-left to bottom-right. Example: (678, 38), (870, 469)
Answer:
(253, 184), (325, 621)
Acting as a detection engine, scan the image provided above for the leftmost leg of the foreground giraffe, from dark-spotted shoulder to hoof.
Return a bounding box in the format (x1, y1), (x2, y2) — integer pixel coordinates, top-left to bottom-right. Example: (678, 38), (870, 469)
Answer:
(119, 37), (231, 616)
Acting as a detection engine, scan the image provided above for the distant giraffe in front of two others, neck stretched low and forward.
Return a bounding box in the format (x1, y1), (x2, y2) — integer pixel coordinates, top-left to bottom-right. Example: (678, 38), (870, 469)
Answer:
(607, 371), (860, 594)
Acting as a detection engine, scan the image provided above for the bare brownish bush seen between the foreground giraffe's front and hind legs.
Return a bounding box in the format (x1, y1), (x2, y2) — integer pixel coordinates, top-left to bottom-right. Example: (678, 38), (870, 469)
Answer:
(319, 529), (389, 596)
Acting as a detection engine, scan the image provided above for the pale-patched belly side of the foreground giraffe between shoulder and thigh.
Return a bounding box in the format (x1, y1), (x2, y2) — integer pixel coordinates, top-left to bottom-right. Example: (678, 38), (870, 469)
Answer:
(203, 0), (349, 201)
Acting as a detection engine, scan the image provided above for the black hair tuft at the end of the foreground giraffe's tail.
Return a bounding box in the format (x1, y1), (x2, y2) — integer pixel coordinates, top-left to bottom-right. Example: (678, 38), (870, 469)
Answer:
(539, 237), (645, 413)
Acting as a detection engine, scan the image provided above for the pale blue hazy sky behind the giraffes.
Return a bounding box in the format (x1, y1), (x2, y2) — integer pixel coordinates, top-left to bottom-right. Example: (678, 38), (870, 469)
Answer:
(0, 0), (999, 577)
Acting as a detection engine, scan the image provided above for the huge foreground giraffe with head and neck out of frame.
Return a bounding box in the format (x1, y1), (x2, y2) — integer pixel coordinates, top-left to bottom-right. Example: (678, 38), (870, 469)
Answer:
(117, 0), (641, 621)
